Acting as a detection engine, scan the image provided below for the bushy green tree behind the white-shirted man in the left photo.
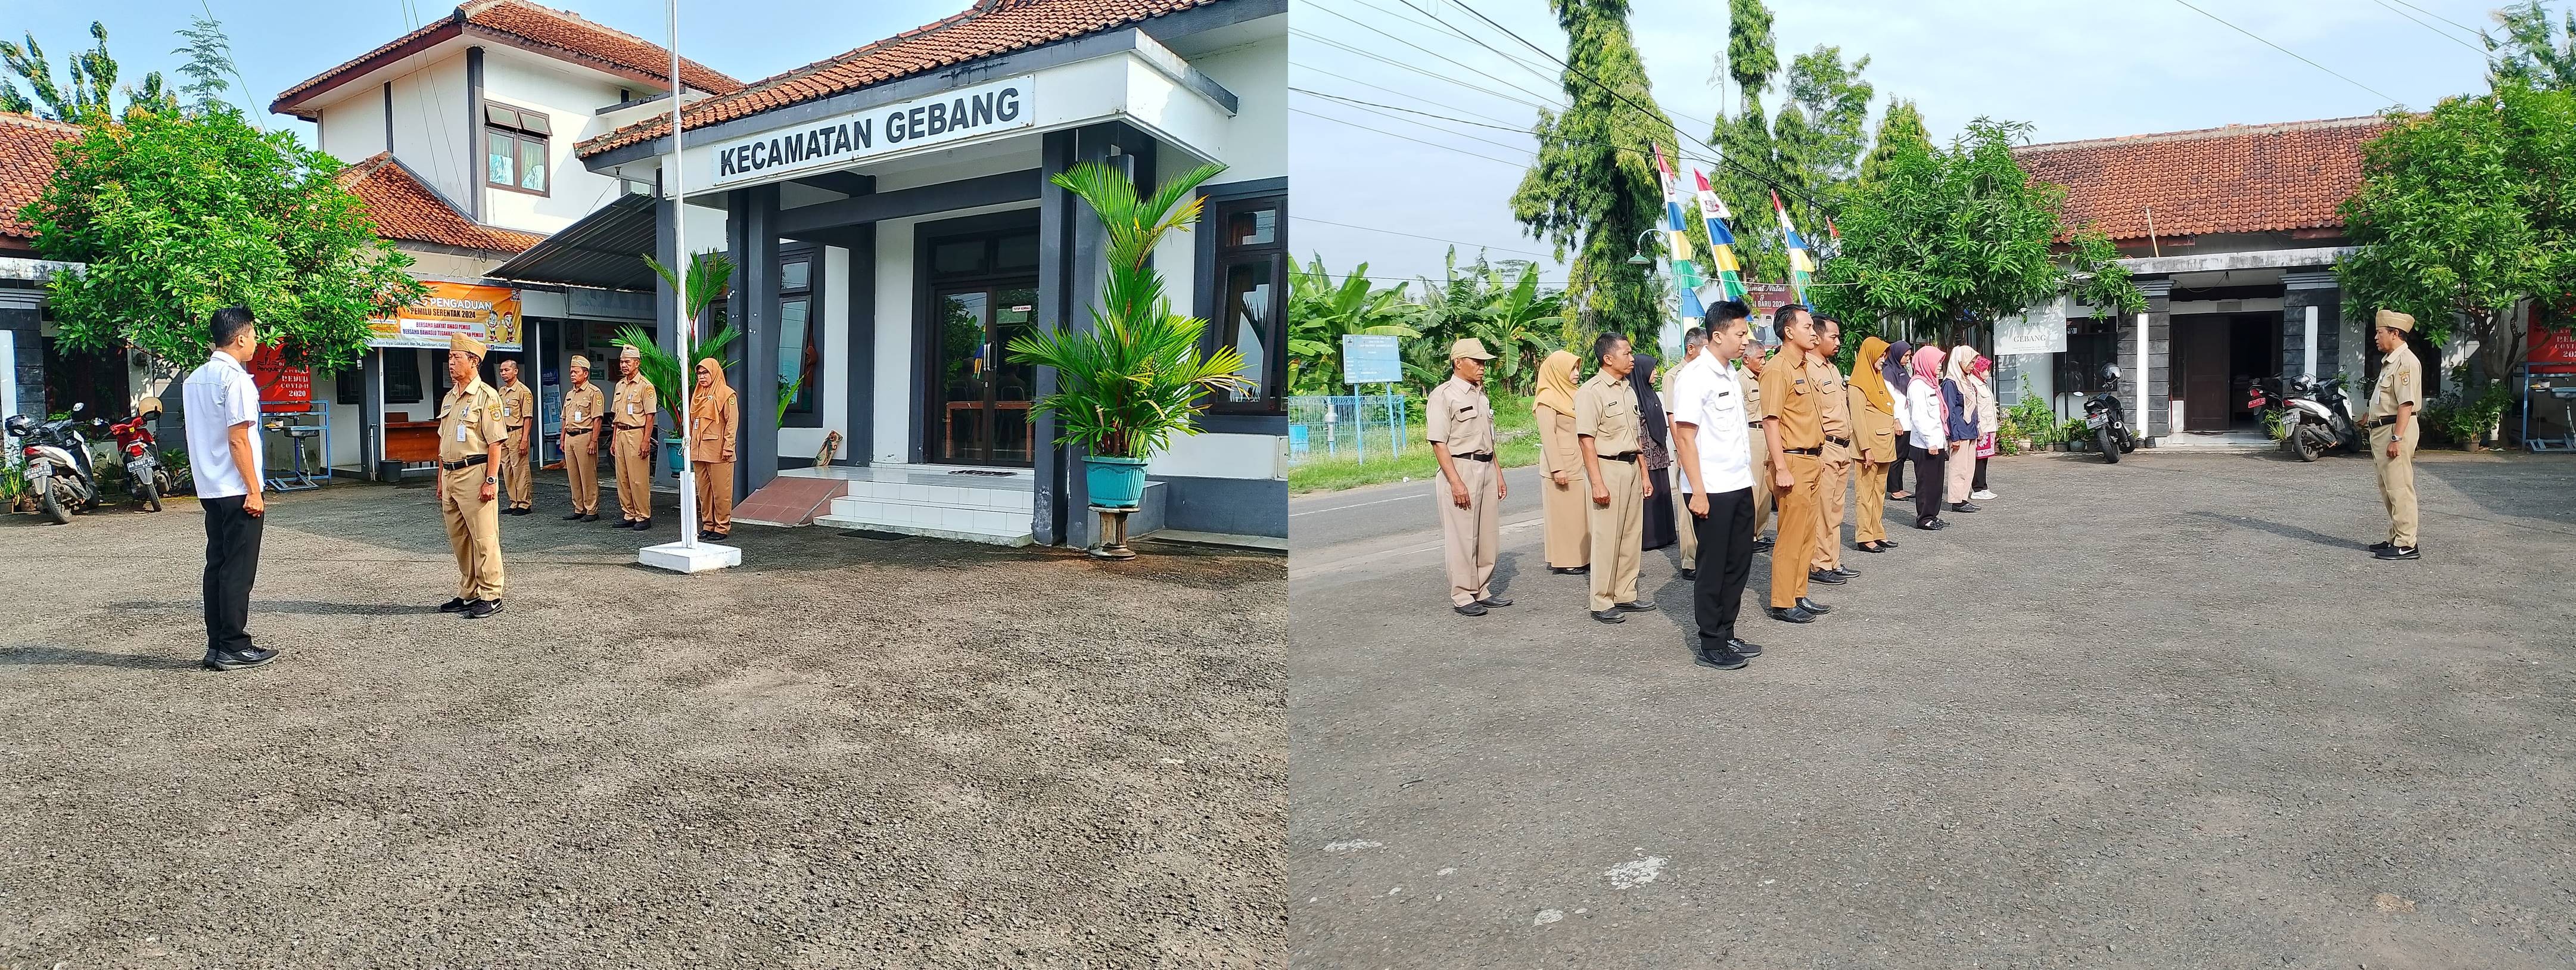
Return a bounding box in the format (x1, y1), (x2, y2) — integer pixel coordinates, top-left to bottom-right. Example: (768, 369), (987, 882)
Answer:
(18, 111), (422, 371)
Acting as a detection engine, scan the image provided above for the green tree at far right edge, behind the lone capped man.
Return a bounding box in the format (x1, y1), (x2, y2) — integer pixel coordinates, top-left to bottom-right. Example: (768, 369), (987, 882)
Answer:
(2334, 80), (2576, 391)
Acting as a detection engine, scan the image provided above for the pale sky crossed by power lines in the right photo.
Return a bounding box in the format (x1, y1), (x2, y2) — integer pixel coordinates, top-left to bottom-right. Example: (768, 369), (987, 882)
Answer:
(1288, 0), (2524, 281)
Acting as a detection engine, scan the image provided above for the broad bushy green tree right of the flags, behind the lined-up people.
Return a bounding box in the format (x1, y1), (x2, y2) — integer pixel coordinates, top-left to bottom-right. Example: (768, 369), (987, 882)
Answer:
(1816, 119), (2146, 345)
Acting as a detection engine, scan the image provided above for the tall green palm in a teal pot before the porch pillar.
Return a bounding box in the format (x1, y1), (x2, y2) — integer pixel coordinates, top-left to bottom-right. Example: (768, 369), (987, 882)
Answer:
(1010, 162), (1255, 509)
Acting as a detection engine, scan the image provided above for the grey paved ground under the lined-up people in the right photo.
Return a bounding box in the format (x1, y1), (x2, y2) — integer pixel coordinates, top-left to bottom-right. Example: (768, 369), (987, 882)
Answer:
(1288, 453), (2576, 968)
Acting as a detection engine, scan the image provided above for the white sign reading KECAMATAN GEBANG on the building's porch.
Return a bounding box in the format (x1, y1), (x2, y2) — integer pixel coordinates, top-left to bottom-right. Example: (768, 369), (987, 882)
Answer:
(714, 74), (1038, 188)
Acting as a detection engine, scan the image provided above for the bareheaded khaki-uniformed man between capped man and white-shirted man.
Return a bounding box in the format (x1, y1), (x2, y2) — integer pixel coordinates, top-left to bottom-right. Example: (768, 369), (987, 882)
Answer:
(1574, 334), (1654, 623)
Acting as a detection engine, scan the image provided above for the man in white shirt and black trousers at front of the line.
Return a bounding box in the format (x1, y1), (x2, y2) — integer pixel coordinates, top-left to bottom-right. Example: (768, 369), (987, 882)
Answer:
(1672, 301), (1762, 669)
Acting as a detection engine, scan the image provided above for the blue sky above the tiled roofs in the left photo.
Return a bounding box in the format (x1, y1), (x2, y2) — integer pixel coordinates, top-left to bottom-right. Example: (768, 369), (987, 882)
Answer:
(0, 0), (971, 139)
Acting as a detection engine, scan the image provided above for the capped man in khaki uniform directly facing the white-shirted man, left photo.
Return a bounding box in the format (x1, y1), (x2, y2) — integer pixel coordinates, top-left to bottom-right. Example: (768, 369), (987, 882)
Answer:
(438, 334), (508, 620)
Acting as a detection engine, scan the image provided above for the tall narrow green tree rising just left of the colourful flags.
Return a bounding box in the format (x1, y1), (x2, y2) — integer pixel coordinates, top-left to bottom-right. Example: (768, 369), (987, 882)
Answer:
(1512, 0), (1675, 340)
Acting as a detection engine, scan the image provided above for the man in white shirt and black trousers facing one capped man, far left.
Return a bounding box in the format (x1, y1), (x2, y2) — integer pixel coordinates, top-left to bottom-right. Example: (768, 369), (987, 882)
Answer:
(183, 306), (278, 669)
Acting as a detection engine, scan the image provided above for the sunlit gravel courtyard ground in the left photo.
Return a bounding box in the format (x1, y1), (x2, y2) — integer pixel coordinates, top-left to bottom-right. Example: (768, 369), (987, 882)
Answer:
(0, 478), (1288, 968)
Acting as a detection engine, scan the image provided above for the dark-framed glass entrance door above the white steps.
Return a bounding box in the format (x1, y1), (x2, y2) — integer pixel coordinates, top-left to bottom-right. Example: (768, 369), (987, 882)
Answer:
(930, 285), (1038, 466)
